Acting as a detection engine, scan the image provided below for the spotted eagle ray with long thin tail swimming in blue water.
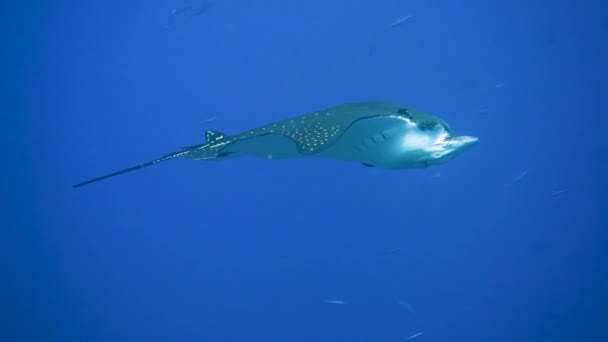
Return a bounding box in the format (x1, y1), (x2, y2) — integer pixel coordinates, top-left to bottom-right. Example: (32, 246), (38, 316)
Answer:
(73, 101), (477, 188)
